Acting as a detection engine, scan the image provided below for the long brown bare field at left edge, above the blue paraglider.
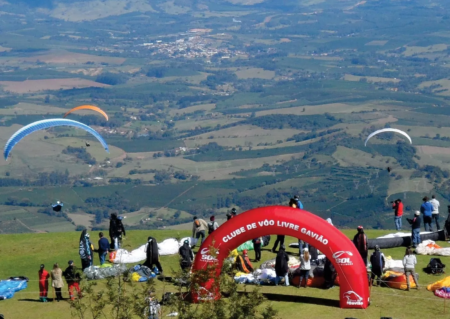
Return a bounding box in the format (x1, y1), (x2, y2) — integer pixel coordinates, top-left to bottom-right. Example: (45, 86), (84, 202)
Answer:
(0, 78), (109, 93)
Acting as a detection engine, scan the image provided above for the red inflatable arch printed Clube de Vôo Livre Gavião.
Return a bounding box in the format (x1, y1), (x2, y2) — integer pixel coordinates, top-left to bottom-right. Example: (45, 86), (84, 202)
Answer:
(192, 206), (370, 309)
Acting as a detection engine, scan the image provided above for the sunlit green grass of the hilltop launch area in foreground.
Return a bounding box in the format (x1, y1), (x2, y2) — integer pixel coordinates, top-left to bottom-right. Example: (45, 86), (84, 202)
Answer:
(0, 230), (450, 319)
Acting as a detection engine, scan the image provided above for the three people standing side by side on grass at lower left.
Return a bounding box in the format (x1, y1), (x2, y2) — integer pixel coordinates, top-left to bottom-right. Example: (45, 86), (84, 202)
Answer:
(38, 260), (81, 302)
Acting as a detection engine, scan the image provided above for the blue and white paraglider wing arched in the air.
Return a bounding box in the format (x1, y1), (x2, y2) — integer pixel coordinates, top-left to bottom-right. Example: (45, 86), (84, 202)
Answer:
(3, 119), (109, 160)
